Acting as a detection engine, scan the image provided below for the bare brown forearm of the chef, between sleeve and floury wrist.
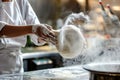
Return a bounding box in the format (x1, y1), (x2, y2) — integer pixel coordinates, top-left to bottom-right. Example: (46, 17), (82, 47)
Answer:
(0, 25), (32, 37)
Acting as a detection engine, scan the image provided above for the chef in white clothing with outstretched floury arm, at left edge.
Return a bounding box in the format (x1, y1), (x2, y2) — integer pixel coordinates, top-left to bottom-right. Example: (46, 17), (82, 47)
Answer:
(0, 0), (56, 74)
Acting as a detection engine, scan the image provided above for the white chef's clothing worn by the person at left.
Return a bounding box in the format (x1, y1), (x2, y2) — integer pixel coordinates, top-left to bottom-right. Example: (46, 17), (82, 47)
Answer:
(0, 0), (40, 74)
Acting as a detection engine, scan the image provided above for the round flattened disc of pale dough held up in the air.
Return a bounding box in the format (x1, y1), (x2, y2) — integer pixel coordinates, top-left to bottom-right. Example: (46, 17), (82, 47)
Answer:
(56, 25), (86, 58)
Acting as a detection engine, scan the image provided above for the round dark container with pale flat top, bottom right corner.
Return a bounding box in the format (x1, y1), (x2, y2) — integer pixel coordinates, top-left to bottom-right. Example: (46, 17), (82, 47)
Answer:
(83, 63), (120, 80)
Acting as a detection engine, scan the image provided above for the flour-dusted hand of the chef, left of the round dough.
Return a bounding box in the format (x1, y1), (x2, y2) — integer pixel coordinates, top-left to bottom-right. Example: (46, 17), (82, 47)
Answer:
(32, 24), (57, 45)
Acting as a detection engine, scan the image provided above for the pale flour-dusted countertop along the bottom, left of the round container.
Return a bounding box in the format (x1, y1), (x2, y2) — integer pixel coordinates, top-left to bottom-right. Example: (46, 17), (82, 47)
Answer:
(0, 65), (89, 80)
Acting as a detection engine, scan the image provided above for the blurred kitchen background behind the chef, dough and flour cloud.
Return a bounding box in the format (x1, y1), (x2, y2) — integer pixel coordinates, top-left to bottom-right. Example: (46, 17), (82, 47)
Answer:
(22, 0), (120, 71)
